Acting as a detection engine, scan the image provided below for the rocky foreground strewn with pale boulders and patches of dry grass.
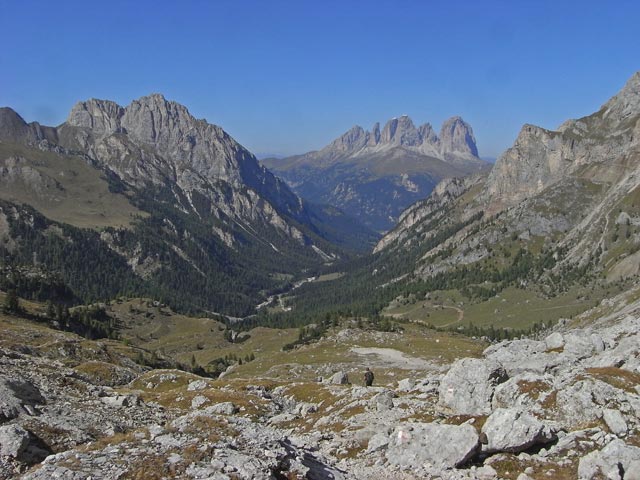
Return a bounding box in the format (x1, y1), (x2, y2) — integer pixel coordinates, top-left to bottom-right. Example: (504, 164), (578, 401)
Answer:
(0, 290), (640, 480)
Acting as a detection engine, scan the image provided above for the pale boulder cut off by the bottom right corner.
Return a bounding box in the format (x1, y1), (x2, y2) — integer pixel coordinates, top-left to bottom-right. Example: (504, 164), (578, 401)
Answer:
(578, 438), (640, 480)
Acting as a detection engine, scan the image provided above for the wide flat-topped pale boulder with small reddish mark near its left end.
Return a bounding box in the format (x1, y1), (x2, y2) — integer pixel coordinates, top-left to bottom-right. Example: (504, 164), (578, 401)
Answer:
(386, 423), (480, 469)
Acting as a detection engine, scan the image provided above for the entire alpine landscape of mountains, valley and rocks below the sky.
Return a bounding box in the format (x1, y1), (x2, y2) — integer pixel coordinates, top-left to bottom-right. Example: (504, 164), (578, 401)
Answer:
(0, 73), (640, 480)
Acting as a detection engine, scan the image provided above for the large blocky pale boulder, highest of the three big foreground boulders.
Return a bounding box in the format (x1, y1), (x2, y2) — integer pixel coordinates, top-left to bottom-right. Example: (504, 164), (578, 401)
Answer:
(438, 358), (507, 415)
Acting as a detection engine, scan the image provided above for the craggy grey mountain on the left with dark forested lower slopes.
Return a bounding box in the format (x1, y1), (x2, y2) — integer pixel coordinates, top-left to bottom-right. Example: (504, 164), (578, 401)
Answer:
(0, 94), (375, 315)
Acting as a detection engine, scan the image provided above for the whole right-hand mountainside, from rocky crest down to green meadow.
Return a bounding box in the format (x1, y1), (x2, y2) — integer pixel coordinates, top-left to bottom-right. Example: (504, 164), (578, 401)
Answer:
(288, 73), (640, 329)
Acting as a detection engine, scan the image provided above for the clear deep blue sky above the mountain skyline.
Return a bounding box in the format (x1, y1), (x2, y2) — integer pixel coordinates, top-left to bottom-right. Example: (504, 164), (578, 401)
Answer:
(0, 0), (640, 156)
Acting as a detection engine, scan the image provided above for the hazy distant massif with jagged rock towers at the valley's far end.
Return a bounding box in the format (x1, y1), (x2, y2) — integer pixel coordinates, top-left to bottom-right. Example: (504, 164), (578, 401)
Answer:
(262, 115), (489, 231)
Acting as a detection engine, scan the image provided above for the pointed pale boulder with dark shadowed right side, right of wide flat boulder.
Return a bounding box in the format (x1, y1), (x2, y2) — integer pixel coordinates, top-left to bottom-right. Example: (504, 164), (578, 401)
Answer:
(482, 408), (557, 453)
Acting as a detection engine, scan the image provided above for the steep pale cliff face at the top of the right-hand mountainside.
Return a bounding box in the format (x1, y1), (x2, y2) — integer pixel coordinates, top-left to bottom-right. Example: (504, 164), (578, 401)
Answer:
(487, 73), (640, 205)
